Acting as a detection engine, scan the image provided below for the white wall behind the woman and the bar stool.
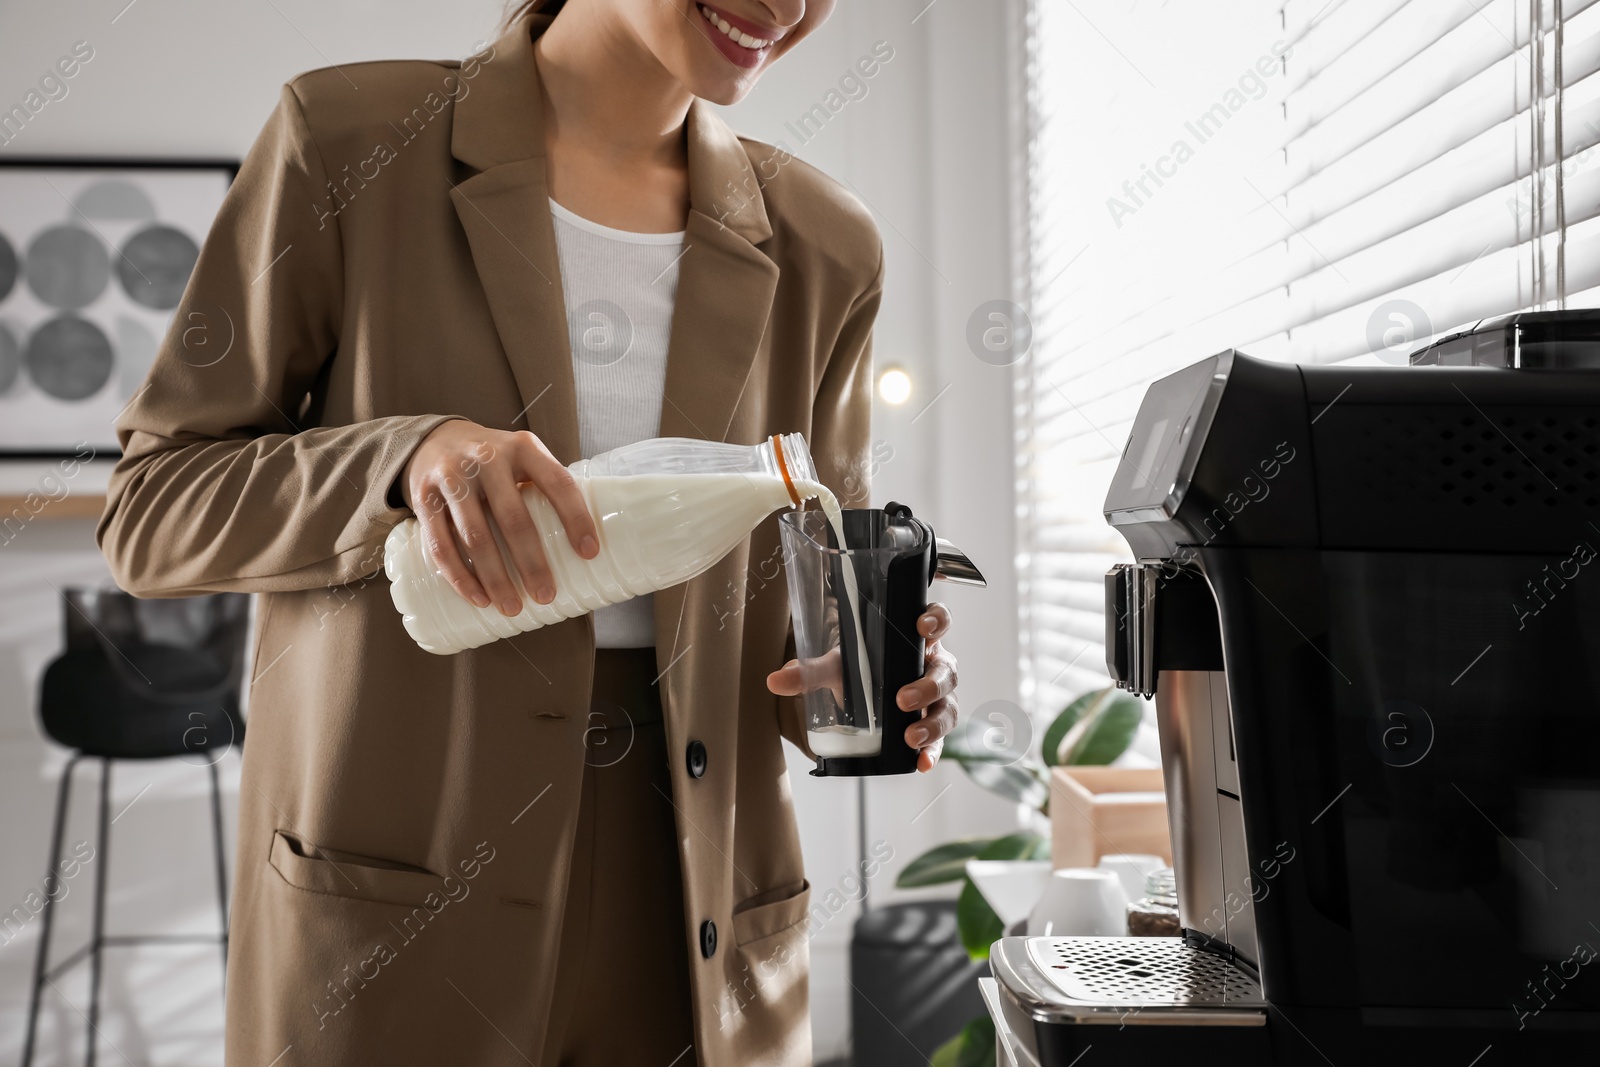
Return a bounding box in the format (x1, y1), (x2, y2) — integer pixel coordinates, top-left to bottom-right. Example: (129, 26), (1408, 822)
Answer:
(0, 0), (1016, 1064)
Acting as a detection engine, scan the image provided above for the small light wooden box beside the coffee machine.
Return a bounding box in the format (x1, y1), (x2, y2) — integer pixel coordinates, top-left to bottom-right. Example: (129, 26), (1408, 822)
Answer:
(1050, 766), (1173, 869)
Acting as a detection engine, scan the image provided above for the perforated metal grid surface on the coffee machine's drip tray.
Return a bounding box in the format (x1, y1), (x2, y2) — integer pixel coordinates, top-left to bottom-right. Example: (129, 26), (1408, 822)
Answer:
(1027, 937), (1266, 1009)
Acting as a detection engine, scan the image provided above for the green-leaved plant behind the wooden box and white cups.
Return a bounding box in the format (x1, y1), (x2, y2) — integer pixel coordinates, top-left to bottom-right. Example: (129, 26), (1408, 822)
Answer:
(894, 686), (1144, 1067)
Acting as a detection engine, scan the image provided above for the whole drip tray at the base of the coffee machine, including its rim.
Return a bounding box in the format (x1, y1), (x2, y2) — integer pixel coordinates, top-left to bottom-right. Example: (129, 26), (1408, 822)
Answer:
(989, 937), (1267, 1027)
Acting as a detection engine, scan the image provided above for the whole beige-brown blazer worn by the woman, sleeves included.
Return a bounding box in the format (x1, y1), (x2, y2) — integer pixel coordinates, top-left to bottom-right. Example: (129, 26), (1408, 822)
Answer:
(99, 14), (883, 1067)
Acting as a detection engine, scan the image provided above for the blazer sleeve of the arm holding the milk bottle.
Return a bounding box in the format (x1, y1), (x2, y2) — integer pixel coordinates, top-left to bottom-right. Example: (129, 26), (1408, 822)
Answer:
(96, 83), (459, 597)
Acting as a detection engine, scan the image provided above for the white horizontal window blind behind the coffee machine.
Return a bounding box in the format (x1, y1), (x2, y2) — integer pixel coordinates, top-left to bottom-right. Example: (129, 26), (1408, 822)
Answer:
(1014, 0), (1600, 726)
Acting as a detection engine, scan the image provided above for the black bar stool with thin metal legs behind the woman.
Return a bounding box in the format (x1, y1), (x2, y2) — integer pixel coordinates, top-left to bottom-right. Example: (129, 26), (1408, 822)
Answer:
(22, 589), (250, 1067)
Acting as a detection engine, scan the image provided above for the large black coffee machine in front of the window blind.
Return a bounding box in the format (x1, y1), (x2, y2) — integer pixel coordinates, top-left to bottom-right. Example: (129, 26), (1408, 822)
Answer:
(986, 312), (1600, 1067)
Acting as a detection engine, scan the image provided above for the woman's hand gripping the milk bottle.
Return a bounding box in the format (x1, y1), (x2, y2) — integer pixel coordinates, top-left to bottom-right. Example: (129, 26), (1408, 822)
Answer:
(400, 419), (600, 616)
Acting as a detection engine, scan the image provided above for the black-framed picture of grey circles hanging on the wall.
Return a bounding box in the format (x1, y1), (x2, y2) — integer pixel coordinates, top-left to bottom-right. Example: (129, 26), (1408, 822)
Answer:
(0, 154), (238, 459)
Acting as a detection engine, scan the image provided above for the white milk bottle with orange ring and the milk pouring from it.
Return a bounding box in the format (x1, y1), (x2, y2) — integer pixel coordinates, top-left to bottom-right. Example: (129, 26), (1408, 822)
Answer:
(384, 434), (880, 757)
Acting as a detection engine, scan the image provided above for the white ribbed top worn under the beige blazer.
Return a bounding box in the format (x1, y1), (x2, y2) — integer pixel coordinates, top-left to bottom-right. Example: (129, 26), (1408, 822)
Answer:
(550, 200), (683, 648)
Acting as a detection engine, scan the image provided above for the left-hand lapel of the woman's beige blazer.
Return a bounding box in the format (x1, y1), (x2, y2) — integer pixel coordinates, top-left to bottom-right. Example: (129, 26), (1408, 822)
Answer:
(450, 14), (579, 464)
